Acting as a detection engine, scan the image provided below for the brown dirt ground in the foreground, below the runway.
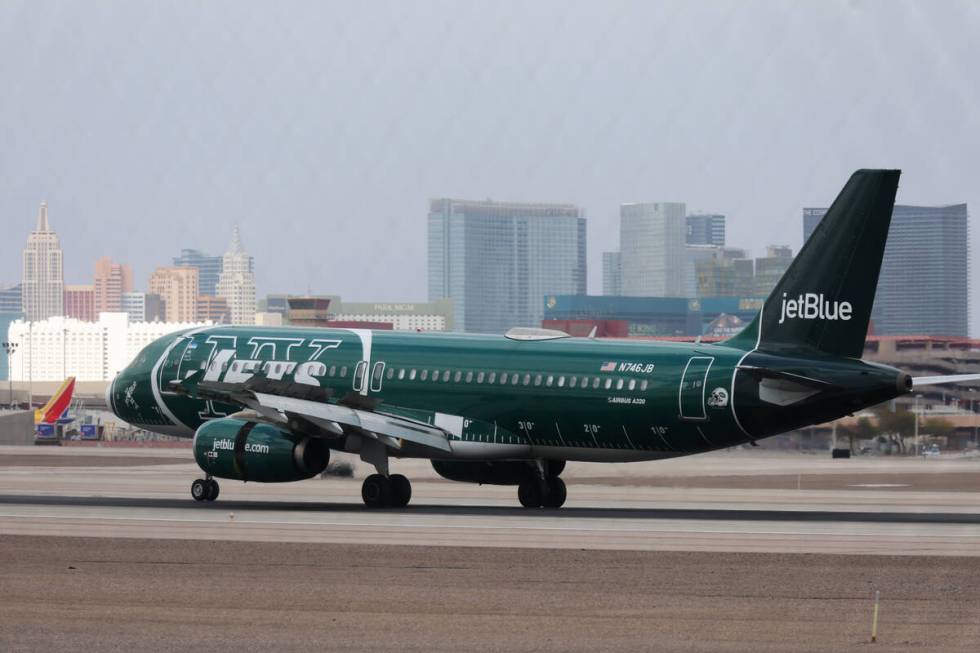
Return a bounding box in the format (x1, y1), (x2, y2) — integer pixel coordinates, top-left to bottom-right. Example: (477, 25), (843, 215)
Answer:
(0, 535), (980, 652)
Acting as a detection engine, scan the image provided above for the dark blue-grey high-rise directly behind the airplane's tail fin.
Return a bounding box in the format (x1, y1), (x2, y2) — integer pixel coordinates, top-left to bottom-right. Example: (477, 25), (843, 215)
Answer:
(803, 204), (970, 336)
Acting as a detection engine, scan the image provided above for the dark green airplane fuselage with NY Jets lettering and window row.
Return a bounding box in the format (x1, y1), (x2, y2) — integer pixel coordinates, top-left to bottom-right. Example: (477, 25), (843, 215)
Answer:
(110, 326), (899, 462)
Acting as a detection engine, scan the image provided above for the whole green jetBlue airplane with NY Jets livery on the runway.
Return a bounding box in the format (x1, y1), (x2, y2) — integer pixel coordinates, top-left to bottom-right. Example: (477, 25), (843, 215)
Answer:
(107, 170), (980, 508)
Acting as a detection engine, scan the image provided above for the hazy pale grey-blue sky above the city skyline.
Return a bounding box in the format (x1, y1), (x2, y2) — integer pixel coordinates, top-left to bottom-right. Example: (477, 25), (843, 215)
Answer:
(0, 0), (980, 333)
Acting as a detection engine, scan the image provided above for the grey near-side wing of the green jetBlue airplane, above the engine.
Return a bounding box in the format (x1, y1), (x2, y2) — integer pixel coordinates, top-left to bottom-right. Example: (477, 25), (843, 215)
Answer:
(170, 372), (452, 451)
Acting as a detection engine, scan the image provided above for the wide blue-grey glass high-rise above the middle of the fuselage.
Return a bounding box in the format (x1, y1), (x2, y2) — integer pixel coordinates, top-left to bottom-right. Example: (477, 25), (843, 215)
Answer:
(428, 198), (586, 333)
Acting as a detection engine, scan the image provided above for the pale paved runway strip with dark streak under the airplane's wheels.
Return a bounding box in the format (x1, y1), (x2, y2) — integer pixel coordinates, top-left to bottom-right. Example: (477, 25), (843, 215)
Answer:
(0, 448), (980, 556)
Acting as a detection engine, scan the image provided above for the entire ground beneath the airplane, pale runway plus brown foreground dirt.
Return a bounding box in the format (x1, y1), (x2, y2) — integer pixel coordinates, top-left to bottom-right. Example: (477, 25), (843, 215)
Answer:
(0, 448), (980, 651)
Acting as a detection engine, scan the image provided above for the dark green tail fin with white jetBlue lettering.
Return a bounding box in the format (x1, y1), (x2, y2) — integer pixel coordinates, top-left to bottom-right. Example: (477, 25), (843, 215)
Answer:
(729, 170), (901, 358)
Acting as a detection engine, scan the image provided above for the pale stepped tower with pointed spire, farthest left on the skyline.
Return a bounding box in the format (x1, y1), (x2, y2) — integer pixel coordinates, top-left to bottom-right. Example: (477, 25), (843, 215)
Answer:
(21, 202), (65, 322)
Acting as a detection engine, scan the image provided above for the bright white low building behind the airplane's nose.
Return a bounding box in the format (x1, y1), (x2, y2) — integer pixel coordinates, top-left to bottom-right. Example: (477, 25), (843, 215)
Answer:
(7, 313), (206, 381)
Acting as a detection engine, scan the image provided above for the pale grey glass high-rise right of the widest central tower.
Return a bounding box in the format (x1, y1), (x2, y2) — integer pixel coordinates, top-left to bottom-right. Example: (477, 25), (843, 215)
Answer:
(619, 202), (693, 297)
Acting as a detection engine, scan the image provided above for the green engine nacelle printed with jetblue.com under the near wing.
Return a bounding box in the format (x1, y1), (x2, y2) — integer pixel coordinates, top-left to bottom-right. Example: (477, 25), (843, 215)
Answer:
(194, 417), (330, 483)
